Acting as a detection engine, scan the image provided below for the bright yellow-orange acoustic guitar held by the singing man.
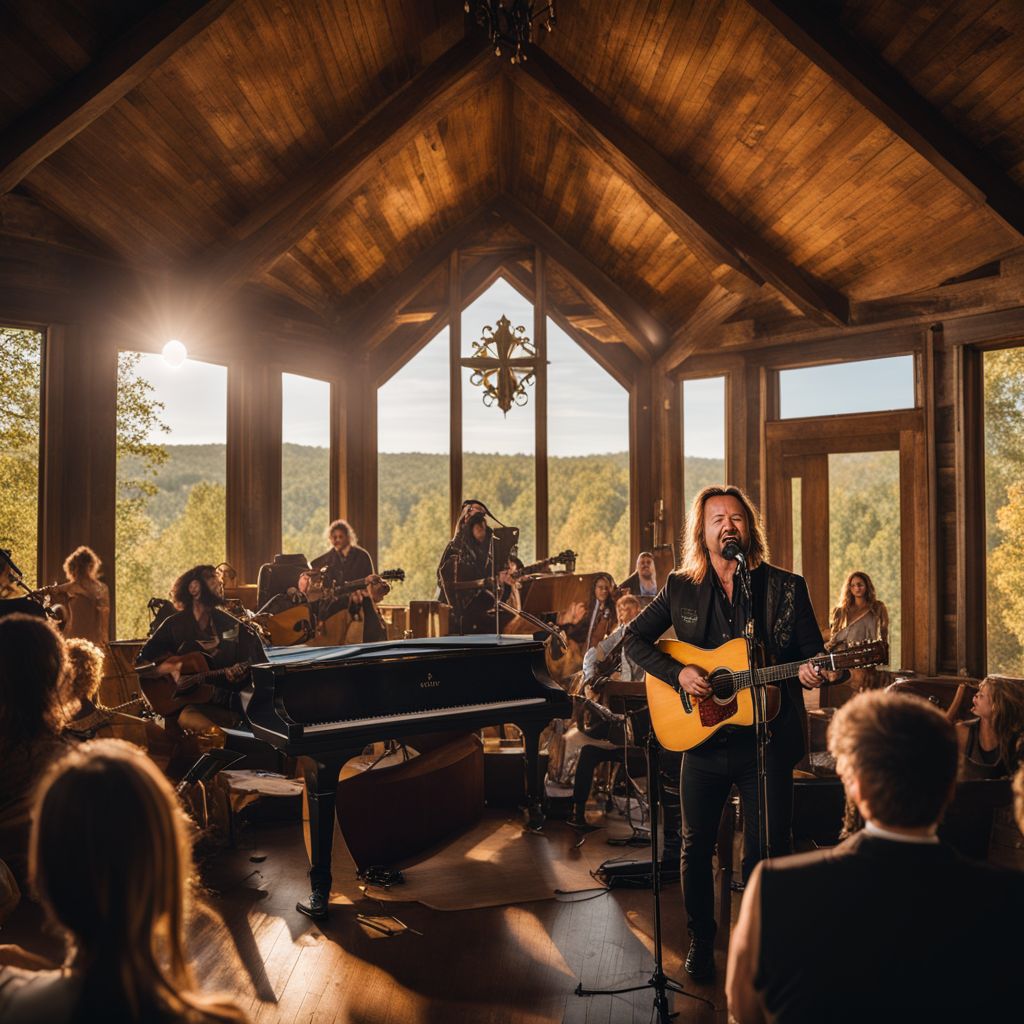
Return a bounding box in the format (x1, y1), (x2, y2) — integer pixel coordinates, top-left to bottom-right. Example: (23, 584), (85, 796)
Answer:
(644, 637), (889, 751)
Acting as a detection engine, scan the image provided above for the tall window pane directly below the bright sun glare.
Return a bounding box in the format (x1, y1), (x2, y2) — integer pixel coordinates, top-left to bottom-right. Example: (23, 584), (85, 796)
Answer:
(117, 352), (227, 637)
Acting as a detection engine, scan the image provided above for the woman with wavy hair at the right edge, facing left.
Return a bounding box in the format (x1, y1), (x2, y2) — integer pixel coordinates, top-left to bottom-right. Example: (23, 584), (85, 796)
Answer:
(956, 676), (1024, 779)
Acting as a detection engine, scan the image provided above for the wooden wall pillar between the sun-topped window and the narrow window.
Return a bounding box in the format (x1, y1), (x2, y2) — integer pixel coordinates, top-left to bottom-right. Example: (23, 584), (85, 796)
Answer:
(225, 353), (282, 584)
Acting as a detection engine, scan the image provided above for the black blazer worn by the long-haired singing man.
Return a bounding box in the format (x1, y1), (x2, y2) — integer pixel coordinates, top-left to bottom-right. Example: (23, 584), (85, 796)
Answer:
(626, 562), (822, 764)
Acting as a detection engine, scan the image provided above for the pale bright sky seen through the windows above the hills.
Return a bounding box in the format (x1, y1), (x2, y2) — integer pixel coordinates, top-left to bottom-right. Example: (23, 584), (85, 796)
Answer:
(130, 290), (913, 450)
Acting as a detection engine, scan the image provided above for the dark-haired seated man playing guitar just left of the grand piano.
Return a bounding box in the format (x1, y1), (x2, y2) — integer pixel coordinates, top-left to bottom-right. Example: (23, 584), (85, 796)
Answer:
(135, 565), (266, 731)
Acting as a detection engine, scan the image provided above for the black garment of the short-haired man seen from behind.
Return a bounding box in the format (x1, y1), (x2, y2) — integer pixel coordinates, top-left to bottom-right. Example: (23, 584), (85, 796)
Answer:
(751, 831), (1024, 1024)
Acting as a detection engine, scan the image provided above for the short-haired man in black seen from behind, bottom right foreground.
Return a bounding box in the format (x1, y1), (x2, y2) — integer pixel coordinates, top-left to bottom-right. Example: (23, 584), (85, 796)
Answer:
(726, 690), (1024, 1024)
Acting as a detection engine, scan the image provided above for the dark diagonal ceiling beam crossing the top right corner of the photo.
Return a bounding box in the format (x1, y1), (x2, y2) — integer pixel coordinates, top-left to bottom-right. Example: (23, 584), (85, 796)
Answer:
(746, 0), (1024, 234)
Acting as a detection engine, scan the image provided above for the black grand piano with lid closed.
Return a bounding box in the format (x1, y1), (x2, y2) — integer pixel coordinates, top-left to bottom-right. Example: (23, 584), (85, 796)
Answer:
(244, 636), (571, 918)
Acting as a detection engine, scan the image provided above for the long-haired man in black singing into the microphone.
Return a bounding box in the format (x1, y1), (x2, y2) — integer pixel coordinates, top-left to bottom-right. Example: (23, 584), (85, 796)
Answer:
(626, 486), (822, 980)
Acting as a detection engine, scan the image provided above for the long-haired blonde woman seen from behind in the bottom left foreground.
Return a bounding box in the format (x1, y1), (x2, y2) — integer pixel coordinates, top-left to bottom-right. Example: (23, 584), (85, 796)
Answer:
(0, 739), (248, 1024)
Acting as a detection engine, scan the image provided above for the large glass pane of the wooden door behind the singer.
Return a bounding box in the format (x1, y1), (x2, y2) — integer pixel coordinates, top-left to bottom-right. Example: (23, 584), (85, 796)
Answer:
(828, 452), (903, 668)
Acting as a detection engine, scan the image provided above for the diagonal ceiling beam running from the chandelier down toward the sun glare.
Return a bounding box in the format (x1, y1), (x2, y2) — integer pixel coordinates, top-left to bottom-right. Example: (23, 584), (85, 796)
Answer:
(202, 40), (498, 300)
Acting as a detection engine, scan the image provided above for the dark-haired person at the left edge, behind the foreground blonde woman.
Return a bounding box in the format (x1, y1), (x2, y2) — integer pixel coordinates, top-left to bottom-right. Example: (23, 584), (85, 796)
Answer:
(0, 614), (68, 889)
